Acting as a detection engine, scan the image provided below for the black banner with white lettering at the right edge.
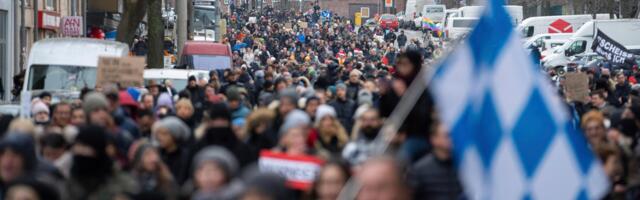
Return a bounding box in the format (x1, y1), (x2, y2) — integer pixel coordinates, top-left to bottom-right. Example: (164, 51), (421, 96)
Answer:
(591, 29), (633, 64)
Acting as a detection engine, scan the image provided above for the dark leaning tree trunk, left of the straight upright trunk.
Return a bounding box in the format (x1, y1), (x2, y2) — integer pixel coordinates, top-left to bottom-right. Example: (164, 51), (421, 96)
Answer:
(116, 0), (147, 45)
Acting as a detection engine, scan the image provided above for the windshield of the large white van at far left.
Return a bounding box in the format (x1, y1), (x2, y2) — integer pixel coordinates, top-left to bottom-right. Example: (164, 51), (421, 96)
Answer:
(28, 65), (97, 91)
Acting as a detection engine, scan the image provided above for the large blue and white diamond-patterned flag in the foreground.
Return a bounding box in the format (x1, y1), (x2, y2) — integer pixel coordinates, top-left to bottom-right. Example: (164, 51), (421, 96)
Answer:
(430, 0), (609, 200)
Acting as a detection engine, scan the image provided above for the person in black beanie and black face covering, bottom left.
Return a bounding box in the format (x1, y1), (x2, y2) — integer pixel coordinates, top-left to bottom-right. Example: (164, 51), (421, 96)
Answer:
(62, 125), (139, 200)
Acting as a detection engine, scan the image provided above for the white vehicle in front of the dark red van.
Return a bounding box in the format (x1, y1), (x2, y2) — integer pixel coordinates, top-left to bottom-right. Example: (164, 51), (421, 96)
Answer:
(143, 69), (209, 91)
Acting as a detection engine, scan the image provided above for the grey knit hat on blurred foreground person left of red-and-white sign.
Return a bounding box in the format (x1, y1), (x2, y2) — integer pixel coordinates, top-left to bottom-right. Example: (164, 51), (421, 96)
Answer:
(193, 146), (239, 179)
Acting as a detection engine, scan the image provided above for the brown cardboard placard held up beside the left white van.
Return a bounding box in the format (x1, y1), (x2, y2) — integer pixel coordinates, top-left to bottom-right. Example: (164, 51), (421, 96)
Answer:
(96, 57), (145, 87)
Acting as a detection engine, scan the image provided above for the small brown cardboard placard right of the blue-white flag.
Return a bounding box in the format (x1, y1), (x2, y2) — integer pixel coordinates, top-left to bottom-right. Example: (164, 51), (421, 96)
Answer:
(565, 73), (589, 103)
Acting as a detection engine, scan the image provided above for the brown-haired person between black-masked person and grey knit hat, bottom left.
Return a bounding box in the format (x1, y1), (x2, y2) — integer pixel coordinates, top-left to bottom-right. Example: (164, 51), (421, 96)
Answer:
(128, 140), (178, 199)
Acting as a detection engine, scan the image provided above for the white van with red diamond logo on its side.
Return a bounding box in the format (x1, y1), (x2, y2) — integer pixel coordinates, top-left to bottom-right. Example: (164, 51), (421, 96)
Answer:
(517, 14), (610, 39)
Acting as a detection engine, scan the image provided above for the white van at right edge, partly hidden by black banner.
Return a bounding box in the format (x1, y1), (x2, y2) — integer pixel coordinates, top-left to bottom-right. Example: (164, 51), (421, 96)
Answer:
(542, 19), (640, 68)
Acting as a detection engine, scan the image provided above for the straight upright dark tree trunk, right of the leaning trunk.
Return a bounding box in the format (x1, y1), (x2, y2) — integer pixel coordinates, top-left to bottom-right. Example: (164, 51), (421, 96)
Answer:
(147, 0), (164, 68)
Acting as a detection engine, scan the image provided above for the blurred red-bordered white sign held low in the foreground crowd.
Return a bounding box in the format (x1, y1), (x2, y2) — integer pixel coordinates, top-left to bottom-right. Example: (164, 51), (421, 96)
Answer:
(258, 150), (324, 190)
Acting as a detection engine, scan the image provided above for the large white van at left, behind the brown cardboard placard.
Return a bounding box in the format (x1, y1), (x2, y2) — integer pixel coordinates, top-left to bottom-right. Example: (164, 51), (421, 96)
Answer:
(22, 38), (129, 103)
